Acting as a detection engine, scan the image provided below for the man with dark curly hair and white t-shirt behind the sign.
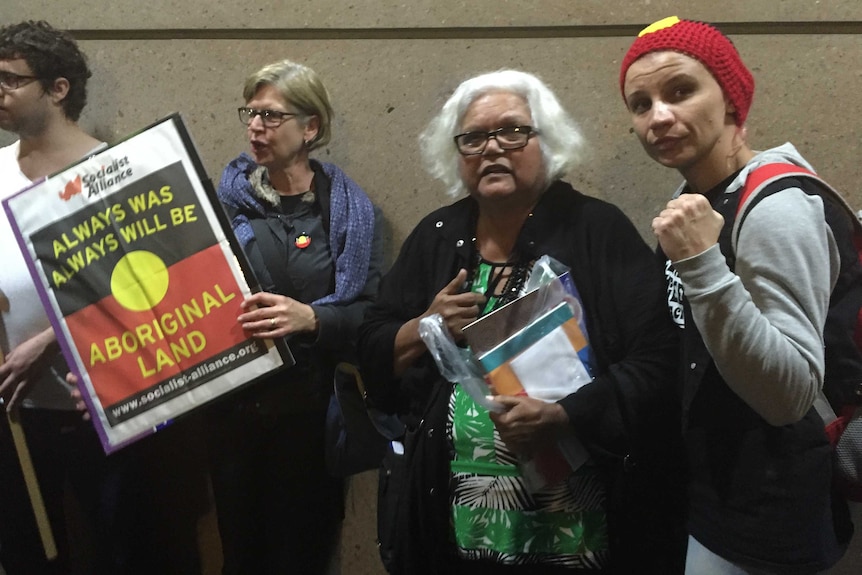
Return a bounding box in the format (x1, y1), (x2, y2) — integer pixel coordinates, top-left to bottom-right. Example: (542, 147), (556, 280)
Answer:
(0, 21), (194, 575)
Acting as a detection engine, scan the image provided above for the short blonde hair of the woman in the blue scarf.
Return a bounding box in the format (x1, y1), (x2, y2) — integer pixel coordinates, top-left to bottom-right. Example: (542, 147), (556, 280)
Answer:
(242, 60), (335, 150)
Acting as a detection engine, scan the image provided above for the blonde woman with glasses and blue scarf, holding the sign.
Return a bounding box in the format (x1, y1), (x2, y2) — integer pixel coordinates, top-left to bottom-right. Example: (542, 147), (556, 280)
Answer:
(209, 60), (382, 575)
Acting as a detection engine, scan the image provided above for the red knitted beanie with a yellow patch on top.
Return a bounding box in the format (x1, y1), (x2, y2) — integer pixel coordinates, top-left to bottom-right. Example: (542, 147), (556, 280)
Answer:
(620, 16), (754, 126)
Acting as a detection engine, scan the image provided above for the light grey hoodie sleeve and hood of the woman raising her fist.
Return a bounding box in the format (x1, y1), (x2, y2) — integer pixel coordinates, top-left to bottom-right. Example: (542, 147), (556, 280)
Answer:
(673, 143), (840, 426)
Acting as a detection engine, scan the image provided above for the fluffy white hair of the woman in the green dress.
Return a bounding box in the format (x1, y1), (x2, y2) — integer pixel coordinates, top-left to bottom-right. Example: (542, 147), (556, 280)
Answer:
(419, 70), (584, 197)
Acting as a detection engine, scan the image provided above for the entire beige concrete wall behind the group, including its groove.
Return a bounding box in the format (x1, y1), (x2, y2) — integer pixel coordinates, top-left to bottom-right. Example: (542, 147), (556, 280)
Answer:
(5, 0), (862, 574)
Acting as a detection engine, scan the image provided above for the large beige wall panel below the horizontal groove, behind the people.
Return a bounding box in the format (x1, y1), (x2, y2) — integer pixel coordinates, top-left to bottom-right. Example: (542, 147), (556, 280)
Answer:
(3, 35), (862, 250)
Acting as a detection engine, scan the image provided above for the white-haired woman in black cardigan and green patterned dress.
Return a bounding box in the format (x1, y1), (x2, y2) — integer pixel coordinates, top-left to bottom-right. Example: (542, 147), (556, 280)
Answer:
(360, 70), (684, 574)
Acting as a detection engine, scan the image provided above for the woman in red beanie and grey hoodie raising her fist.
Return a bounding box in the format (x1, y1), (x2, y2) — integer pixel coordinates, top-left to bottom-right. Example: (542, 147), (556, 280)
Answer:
(620, 17), (855, 575)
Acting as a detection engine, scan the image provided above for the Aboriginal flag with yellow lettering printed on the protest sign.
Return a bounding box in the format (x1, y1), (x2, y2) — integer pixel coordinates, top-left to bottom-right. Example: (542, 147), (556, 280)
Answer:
(31, 162), (266, 423)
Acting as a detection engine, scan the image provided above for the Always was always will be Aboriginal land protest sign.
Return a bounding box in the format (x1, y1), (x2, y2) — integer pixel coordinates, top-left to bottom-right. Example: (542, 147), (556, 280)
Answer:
(3, 115), (293, 452)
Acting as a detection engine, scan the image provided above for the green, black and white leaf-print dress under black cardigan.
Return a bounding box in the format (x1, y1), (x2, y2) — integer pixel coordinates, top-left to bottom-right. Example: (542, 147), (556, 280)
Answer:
(447, 260), (608, 569)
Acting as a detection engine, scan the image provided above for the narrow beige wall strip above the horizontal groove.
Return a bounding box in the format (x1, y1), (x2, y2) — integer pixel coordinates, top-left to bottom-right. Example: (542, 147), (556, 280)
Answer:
(5, 0), (862, 30)
